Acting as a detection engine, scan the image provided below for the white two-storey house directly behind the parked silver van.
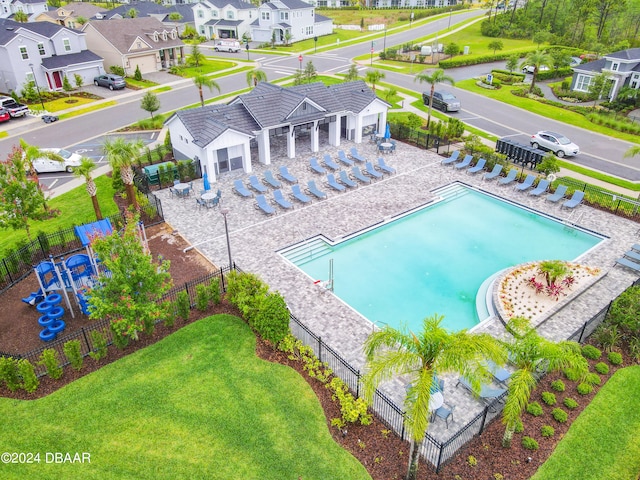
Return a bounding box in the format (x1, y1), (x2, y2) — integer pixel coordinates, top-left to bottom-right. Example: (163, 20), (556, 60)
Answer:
(192, 0), (258, 40)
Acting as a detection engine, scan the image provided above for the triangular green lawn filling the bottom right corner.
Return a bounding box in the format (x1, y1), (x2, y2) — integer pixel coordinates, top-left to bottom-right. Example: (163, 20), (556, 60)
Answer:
(532, 366), (640, 480)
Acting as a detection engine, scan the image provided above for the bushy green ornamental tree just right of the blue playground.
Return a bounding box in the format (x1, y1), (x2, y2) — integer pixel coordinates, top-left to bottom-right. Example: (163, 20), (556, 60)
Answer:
(89, 216), (172, 345)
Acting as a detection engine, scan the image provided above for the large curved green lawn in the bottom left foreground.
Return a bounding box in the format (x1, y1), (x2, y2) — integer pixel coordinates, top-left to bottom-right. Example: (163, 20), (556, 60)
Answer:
(0, 315), (370, 480)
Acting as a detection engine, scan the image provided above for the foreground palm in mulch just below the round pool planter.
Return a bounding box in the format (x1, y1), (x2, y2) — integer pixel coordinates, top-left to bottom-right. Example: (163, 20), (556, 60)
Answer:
(502, 317), (589, 447)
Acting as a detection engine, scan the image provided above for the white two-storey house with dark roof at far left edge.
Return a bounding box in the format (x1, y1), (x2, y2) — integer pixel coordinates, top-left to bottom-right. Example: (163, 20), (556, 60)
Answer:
(0, 19), (104, 92)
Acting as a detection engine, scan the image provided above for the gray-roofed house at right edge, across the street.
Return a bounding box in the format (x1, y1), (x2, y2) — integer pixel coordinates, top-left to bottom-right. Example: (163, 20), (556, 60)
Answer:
(571, 48), (640, 100)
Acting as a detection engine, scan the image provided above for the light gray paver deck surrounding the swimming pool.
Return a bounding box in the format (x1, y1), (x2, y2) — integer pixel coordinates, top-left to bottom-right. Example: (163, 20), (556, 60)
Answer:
(156, 135), (640, 441)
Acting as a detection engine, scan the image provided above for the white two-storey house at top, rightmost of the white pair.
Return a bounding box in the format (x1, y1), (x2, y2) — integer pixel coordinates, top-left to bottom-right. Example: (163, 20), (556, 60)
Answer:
(251, 0), (333, 44)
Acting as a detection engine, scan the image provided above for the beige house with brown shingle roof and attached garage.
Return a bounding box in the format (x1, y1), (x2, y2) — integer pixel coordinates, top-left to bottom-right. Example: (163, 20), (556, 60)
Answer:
(82, 17), (185, 76)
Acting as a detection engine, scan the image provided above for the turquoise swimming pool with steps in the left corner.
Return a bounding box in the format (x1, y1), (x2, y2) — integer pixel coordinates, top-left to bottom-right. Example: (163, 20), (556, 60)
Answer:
(280, 184), (603, 331)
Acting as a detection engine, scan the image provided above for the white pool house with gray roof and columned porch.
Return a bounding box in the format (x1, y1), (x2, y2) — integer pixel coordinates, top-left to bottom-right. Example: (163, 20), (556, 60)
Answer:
(165, 80), (390, 180)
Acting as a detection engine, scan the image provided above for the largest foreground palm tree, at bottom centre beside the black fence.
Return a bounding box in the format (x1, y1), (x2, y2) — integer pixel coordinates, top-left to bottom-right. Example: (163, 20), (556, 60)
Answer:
(362, 314), (506, 480)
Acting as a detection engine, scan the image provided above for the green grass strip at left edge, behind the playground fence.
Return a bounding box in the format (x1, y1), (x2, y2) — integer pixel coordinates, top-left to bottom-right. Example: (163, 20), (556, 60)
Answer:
(0, 175), (118, 252)
